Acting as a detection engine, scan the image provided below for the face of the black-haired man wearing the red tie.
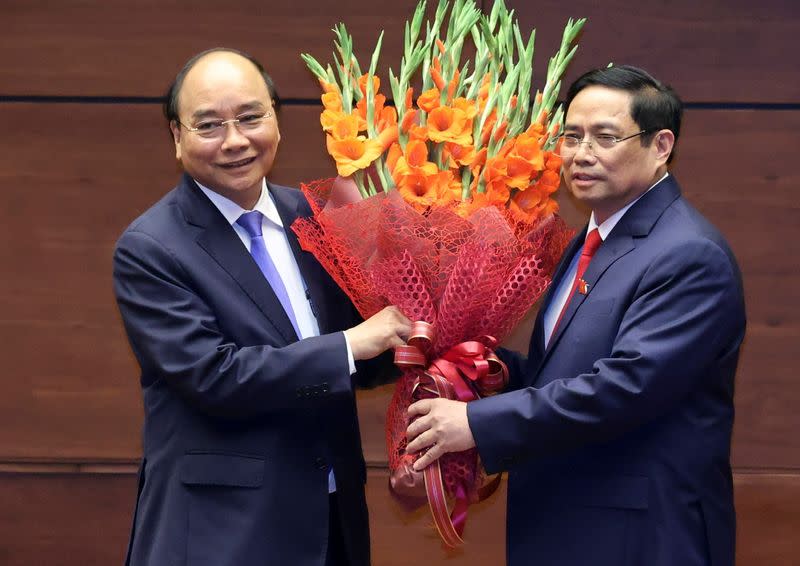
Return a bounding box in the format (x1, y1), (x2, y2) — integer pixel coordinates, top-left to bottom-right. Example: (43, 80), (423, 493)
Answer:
(563, 85), (672, 224)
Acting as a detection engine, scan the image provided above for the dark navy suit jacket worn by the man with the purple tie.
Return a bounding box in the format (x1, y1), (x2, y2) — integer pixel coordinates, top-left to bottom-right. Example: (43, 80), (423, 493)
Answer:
(114, 176), (369, 566)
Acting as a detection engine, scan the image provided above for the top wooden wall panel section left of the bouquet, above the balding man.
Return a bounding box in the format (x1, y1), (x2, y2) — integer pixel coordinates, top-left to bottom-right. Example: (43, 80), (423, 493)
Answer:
(0, 0), (432, 98)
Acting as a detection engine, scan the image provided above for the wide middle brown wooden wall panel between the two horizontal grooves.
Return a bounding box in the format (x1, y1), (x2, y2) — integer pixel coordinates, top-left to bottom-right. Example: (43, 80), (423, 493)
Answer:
(0, 103), (800, 468)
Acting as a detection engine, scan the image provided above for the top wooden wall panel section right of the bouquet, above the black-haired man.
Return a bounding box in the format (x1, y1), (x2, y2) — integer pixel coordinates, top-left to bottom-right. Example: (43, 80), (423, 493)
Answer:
(510, 0), (800, 102)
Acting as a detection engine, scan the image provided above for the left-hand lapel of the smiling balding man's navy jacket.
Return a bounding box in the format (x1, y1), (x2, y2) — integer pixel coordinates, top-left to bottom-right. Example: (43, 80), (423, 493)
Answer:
(179, 175), (297, 344)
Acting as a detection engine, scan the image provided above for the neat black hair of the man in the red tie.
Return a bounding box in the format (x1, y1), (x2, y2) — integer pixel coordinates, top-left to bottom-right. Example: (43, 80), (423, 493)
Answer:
(565, 65), (683, 163)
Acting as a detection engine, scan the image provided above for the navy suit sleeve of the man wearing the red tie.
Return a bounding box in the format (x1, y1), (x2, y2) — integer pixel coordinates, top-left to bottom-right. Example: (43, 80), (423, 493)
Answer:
(468, 241), (744, 472)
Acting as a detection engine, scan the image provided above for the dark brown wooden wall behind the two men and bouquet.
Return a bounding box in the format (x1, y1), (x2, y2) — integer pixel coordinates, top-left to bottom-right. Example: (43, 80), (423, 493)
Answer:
(0, 0), (800, 566)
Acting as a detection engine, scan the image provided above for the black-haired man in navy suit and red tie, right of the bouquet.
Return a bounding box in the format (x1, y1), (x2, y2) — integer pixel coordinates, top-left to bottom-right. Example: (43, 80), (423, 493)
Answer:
(408, 66), (745, 566)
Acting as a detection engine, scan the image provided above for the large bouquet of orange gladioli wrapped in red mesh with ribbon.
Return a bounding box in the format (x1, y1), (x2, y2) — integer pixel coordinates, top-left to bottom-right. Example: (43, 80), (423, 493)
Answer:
(293, 0), (585, 546)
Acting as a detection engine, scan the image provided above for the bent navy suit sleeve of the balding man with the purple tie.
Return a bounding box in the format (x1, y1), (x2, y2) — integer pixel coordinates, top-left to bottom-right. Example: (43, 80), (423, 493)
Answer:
(114, 231), (352, 419)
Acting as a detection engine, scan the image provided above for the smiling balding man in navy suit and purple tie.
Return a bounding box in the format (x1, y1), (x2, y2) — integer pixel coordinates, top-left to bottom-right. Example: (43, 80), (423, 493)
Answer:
(114, 49), (408, 566)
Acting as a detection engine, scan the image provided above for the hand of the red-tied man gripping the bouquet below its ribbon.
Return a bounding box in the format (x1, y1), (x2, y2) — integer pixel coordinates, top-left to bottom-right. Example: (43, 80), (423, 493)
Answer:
(406, 399), (475, 471)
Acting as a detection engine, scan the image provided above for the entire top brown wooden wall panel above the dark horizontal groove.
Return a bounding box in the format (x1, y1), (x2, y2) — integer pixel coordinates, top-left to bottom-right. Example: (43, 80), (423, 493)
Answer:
(0, 0), (800, 103)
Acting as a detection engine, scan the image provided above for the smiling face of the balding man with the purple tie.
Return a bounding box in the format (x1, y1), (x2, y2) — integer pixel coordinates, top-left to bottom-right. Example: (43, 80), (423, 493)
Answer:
(170, 52), (280, 209)
